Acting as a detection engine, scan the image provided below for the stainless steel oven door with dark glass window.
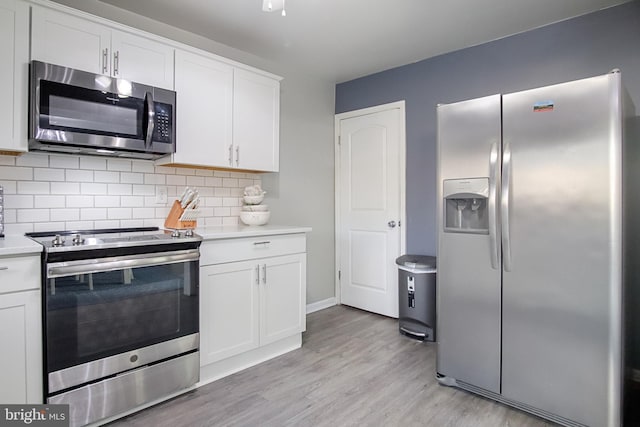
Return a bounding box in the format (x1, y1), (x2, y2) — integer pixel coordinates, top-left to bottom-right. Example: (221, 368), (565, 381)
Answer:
(45, 249), (199, 393)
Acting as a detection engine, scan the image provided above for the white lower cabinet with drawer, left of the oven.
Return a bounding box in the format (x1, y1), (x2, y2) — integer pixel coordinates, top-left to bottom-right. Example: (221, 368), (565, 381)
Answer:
(0, 256), (42, 404)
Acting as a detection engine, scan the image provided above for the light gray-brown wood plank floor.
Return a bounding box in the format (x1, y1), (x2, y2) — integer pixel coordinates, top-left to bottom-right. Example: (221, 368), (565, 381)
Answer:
(111, 306), (553, 427)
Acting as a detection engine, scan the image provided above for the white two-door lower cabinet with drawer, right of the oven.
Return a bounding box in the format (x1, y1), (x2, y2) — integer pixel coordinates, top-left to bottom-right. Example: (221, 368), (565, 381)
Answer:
(200, 235), (306, 366)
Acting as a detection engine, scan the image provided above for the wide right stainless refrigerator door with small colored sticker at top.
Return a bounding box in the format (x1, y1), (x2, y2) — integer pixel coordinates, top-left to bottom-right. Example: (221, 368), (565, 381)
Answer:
(501, 74), (622, 426)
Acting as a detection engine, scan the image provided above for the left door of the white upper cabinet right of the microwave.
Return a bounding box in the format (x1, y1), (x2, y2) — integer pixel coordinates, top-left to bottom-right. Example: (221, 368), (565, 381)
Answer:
(172, 50), (233, 168)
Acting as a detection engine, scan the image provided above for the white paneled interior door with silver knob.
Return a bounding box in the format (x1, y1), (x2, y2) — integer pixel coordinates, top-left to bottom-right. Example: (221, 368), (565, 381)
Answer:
(336, 102), (404, 317)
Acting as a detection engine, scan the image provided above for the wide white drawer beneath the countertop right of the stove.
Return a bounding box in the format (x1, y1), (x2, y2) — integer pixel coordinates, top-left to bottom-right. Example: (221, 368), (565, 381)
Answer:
(200, 233), (307, 265)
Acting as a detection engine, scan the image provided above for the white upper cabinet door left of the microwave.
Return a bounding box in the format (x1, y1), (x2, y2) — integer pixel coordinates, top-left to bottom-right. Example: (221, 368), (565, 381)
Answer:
(0, 0), (29, 154)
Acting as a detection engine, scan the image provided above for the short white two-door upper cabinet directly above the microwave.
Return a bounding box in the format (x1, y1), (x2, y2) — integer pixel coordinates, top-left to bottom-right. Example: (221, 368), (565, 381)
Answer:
(31, 6), (173, 89)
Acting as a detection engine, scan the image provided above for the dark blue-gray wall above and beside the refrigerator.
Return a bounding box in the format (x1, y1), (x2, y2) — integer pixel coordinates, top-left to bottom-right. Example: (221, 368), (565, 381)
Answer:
(336, 1), (640, 255)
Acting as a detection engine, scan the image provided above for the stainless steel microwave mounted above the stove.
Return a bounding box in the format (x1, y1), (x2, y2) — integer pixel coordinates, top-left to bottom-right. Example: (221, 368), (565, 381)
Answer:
(29, 61), (176, 159)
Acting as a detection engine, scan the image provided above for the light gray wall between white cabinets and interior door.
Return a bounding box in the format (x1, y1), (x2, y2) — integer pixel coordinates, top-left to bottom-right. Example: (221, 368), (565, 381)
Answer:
(48, 0), (335, 303)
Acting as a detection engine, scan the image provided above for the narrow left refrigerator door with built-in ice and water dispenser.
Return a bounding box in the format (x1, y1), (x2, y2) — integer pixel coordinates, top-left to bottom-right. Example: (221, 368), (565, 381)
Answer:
(436, 95), (501, 393)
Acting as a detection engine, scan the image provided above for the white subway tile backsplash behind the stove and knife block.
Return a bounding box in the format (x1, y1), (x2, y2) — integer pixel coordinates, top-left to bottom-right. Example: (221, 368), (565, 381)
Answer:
(0, 153), (261, 235)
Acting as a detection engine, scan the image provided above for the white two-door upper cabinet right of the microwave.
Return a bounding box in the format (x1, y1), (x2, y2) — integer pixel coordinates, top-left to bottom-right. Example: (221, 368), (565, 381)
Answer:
(157, 50), (280, 172)
